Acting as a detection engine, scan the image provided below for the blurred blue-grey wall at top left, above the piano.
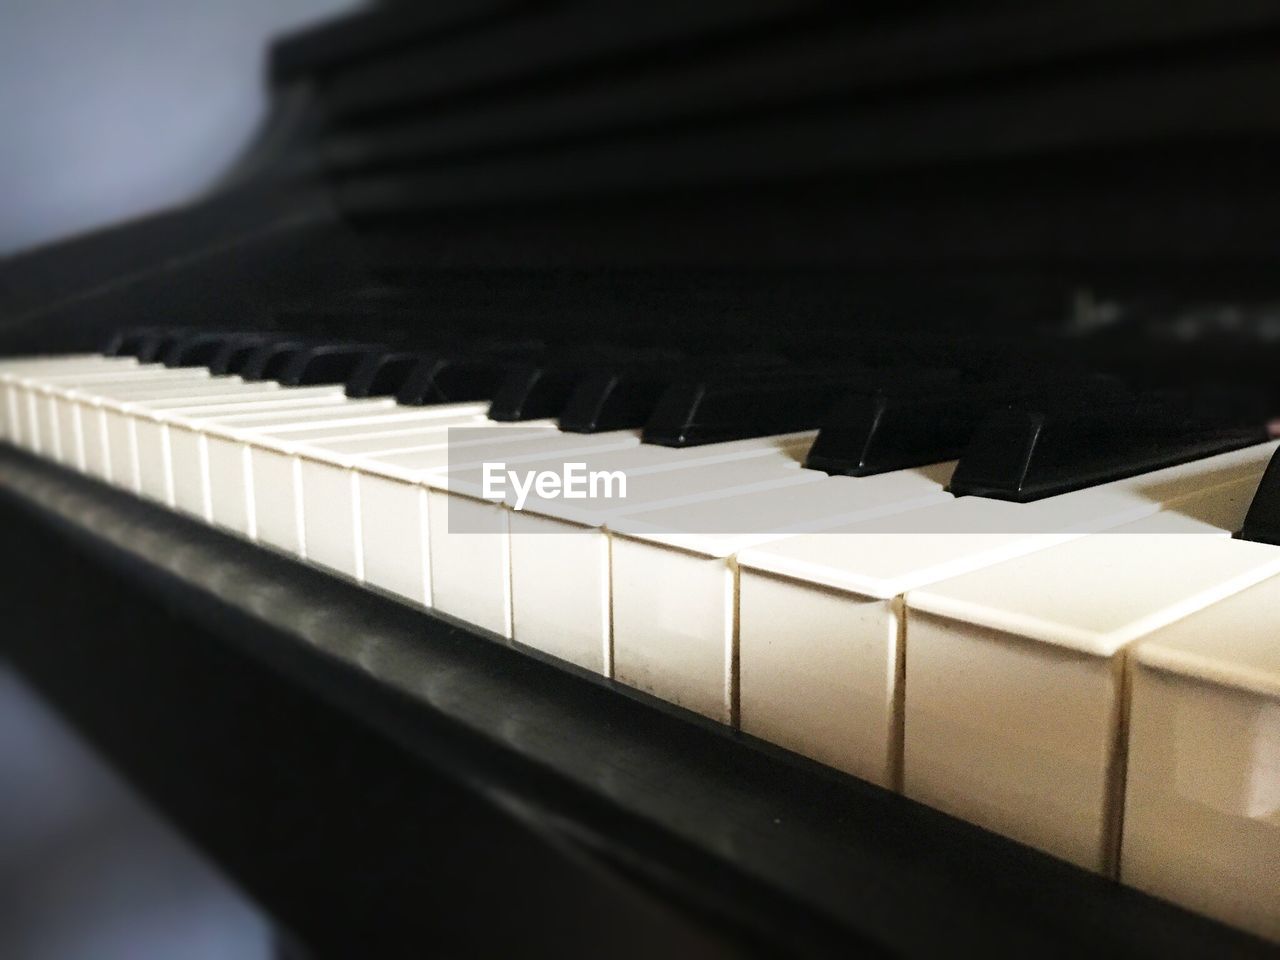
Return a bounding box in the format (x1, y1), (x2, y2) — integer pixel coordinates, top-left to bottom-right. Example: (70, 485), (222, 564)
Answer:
(0, 0), (356, 255)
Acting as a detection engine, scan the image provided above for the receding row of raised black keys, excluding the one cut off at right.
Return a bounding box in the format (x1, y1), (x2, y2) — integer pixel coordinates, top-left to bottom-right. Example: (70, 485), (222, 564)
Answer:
(105, 328), (1280, 514)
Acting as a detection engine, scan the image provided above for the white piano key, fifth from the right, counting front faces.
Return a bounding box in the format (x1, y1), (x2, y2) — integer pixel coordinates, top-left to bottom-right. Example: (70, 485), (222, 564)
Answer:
(506, 431), (822, 676)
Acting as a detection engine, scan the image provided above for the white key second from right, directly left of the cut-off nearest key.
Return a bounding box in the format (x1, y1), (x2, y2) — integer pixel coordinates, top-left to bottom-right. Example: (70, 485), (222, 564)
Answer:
(902, 483), (1280, 874)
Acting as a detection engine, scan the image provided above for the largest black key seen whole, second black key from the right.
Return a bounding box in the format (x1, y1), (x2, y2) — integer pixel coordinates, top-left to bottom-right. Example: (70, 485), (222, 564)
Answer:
(950, 397), (1266, 503)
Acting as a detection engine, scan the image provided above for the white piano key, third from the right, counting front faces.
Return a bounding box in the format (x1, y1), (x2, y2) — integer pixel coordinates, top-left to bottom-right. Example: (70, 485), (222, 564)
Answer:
(737, 444), (1275, 788)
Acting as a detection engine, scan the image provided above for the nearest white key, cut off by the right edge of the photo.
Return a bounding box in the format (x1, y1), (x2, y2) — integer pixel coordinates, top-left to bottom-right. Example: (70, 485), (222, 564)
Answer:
(1120, 579), (1280, 941)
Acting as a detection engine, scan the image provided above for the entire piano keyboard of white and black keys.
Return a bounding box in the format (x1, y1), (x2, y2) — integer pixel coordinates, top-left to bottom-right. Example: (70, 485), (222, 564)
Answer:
(0, 332), (1280, 940)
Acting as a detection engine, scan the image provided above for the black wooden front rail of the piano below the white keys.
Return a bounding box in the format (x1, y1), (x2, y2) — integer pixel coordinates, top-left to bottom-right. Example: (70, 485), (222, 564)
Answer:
(0, 447), (1274, 957)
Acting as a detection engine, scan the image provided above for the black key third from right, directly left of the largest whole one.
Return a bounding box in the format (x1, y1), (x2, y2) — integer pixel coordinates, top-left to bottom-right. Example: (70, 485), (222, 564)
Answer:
(805, 376), (1124, 476)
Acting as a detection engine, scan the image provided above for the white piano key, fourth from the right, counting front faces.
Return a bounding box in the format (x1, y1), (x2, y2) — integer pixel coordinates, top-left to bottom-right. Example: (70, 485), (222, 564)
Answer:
(609, 463), (954, 723)
